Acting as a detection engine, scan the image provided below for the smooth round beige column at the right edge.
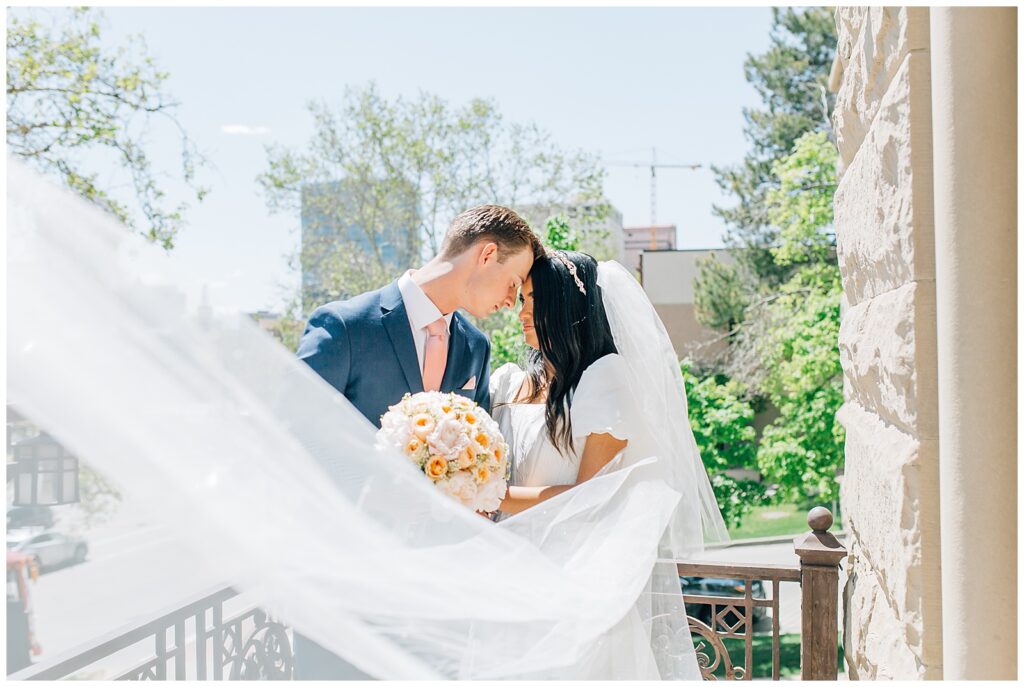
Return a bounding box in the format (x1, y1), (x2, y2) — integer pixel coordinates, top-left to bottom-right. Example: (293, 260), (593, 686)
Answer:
(931, 7), (1017, 680)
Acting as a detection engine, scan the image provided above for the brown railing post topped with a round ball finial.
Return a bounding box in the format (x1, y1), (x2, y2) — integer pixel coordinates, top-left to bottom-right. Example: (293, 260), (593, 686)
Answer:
(793, 506), (846, 680)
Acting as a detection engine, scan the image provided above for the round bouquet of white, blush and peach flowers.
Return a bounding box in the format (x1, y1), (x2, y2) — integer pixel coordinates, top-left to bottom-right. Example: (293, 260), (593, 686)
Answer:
(377, 391), (509, 512)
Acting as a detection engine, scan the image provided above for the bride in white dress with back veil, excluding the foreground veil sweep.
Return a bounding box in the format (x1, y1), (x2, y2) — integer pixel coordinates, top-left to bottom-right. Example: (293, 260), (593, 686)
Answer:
(490, 251), (724, 679)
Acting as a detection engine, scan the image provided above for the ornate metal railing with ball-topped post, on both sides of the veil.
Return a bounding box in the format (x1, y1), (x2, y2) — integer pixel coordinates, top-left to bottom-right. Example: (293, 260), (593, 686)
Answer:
(7, 508), (846, 680)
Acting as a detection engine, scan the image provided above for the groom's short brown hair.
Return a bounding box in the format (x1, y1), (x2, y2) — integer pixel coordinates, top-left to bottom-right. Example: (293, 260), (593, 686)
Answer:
(441, 205), (544, 262)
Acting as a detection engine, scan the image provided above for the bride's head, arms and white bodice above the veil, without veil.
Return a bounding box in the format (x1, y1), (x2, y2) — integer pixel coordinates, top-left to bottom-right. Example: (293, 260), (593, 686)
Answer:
(490, 251), (637, 514)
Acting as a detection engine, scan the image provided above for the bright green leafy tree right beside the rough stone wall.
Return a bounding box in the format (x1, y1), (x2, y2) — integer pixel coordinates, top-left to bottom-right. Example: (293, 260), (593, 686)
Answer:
(734, 132), (845, 500)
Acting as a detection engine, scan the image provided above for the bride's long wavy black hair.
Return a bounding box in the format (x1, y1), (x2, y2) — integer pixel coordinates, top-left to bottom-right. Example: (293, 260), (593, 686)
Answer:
(525, 251), (618, 455)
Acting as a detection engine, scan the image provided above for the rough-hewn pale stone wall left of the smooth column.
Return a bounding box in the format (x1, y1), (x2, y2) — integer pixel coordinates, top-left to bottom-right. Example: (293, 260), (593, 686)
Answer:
(833, 7), (942, 679)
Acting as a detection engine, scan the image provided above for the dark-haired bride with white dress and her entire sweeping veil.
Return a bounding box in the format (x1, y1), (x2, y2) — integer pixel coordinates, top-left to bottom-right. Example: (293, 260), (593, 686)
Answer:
(6, 161), (721, 679)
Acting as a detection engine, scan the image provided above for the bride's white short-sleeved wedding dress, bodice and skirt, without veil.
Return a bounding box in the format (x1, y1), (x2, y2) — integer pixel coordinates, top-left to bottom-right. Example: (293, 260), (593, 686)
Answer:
(490, 353), (700, 680)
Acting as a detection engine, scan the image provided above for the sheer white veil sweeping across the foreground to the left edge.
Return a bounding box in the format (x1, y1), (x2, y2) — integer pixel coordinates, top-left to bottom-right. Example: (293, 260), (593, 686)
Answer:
(7, 160), (704, 679)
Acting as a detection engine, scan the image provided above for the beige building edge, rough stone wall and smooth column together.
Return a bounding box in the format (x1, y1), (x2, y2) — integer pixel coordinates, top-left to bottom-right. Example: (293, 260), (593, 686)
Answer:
(831, 7), (1017, 679)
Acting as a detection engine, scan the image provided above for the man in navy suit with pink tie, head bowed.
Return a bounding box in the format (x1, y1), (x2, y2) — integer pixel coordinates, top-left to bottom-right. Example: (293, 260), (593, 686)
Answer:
(295, 205), (543, 680)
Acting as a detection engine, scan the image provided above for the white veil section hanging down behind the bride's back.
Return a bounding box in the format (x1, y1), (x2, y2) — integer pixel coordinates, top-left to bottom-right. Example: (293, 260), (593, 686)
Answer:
(597, 261), (729, 559)
